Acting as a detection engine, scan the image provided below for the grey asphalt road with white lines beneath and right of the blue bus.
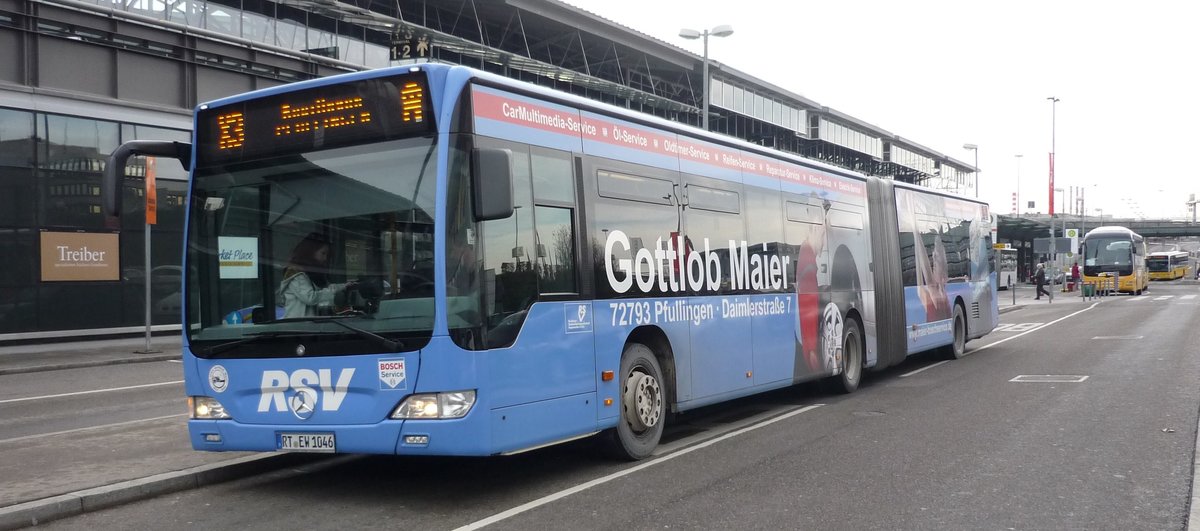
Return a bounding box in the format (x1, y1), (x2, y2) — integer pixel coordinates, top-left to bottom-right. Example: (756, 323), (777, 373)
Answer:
(28, 285), (1200, 531)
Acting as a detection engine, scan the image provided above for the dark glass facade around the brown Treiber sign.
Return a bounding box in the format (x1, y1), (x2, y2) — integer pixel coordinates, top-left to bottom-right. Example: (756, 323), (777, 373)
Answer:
(0, 108), (188, 334)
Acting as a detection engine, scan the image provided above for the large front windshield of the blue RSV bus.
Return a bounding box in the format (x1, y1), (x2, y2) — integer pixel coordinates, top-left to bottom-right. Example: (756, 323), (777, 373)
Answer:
(187, 136), (437, 357)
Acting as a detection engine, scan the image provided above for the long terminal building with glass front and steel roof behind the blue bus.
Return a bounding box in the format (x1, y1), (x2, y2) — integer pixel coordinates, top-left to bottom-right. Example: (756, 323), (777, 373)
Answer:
(0, 0), (977, 340)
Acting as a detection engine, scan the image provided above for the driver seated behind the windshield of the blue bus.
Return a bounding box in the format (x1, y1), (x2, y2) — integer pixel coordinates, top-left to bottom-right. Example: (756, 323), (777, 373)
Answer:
(275, 233), (354, 318)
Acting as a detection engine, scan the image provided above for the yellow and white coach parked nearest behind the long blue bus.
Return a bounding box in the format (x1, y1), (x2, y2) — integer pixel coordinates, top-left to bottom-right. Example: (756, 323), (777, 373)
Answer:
(1081, 227), (1150, 296)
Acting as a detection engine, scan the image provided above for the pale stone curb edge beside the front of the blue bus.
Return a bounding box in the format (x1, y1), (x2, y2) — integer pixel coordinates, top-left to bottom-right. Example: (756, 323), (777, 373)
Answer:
(0, 453), (324, 530)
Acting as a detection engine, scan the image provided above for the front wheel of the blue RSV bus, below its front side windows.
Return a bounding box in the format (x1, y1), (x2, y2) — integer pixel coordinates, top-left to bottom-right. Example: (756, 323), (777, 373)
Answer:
(604, 342), (666, 460)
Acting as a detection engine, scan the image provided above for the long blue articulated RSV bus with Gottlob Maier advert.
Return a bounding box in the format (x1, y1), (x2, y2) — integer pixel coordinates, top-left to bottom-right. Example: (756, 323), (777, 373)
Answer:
(104, 64), (998, 459)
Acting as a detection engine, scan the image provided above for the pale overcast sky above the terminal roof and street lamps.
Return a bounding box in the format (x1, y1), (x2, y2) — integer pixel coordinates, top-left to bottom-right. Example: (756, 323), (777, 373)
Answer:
(565, 0), (1200, 217)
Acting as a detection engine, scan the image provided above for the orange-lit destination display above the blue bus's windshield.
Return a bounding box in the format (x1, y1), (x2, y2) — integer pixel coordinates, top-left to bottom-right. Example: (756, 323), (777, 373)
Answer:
(198, 74), (433, 165)
